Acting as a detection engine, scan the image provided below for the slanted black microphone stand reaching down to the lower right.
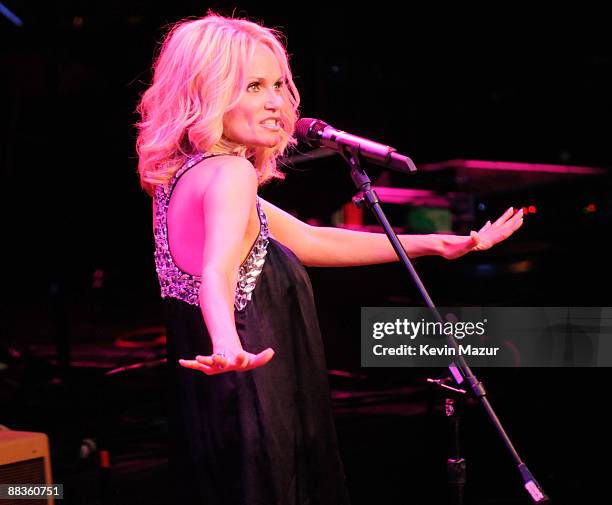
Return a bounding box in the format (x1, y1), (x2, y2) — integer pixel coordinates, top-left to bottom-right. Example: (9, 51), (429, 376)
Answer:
(340, 146), (550, 504)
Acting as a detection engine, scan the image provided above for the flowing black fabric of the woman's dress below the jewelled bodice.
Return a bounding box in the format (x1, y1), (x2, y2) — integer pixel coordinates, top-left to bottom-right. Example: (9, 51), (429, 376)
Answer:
(156, 154), (349, 505)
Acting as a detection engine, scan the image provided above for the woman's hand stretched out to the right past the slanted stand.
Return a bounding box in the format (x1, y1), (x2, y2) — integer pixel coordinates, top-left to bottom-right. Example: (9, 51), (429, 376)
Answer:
(442, 207), (523, 260)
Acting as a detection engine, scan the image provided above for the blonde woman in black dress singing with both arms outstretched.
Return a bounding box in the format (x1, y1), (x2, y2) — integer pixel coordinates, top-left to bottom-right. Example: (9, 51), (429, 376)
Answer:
(137, 14), (522, 505)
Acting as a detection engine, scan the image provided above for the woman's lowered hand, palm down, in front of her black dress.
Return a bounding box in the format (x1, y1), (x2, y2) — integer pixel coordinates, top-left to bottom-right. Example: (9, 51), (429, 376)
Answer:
(179, 348), (274, 375)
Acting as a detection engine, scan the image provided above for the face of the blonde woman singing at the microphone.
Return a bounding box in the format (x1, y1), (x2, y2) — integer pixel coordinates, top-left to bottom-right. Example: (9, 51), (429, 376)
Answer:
(223, 44), (285, 148)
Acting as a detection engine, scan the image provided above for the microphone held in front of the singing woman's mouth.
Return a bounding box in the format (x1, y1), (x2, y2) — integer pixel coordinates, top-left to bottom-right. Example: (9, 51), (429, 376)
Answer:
(295, 118), (416, 173)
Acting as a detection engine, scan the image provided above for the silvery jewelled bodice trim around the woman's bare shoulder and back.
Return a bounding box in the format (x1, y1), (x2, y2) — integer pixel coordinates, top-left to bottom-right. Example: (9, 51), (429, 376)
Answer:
(154, 153), (269, 310)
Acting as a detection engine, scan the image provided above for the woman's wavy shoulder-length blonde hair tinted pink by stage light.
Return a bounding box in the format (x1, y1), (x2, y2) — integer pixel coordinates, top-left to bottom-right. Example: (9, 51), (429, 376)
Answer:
(136, 13), (300, 194)
